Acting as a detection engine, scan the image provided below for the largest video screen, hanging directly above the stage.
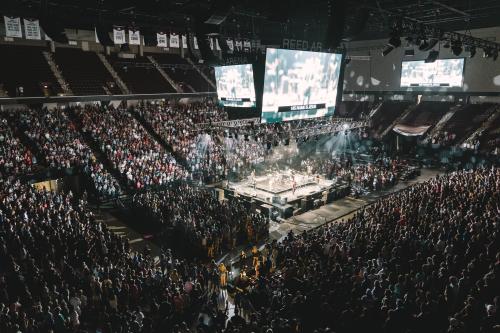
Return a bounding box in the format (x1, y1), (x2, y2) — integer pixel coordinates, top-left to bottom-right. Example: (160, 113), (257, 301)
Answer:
(261, 49), (342, 123)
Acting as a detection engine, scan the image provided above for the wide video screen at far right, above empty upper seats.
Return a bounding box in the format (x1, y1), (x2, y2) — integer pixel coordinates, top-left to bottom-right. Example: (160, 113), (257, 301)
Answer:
(401, 58), (464, 87)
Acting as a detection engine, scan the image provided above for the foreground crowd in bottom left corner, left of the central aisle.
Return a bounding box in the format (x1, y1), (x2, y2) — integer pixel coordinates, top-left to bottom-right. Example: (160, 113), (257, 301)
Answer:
(0, 179), (237, 333)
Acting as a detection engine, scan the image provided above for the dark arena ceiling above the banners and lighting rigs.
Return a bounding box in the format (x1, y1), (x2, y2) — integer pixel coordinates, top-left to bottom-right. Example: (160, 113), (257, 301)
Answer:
(0, 0), (500, 39)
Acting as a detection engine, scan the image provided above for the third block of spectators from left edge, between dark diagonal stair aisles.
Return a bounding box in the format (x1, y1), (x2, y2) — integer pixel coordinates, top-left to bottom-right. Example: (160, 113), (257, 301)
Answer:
(75, 106), (188, 190)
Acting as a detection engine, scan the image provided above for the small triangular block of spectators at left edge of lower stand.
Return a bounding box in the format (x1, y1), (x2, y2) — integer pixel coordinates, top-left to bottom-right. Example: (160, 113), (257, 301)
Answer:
(0, 115), (38, 178)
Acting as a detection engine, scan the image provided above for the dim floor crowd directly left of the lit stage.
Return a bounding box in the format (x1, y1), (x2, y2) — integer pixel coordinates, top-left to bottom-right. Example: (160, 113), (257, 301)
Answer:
(133, 185), (269, 258)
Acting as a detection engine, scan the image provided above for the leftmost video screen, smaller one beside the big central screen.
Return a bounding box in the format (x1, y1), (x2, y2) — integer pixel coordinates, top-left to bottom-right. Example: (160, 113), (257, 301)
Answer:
(215, 64), (255, 107)
